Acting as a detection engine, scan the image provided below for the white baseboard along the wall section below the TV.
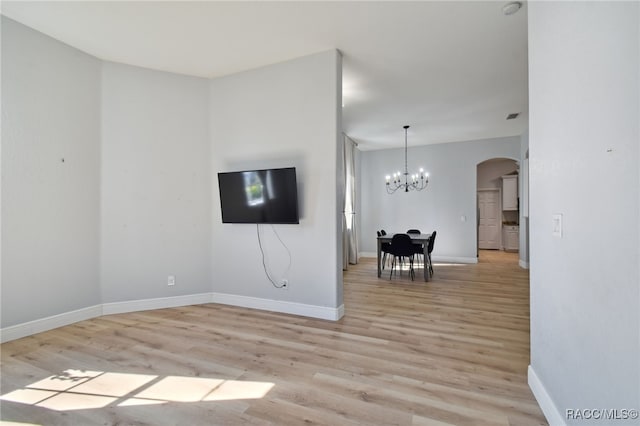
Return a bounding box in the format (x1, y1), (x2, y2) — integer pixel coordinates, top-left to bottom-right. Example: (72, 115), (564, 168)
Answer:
(212, 293), (344, 321)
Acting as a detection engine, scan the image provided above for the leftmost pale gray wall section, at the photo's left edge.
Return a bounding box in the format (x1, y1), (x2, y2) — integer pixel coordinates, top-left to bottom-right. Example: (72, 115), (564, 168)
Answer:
(1, 16), (100, 328)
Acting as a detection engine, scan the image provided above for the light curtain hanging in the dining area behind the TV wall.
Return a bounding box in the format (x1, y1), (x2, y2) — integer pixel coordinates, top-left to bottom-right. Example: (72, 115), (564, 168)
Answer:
(342, 135), (358, 270)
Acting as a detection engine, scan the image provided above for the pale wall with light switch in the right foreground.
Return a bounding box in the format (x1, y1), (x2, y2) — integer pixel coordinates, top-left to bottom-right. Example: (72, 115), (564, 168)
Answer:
(529, 2), (640, 424)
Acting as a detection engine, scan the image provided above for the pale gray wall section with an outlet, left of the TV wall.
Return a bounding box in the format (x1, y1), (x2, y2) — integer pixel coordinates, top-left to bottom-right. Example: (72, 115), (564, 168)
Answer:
(101, 62), (212, 303)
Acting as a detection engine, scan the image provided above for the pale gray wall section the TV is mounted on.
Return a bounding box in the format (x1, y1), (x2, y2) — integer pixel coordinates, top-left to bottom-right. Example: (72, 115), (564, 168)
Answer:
(210, 51), (342, 309)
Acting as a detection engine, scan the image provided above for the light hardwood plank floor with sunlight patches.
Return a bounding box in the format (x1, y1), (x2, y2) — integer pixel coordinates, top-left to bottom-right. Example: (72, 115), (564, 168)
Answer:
(0, 251), (546, 426)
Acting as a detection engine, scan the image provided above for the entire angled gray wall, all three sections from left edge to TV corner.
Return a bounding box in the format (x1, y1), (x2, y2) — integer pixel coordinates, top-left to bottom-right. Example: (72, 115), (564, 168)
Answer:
(1, 17), (342, 328)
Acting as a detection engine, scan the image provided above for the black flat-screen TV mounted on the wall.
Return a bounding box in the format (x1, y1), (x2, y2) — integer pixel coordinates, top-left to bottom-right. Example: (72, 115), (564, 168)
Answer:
(218, 167), (300, 223)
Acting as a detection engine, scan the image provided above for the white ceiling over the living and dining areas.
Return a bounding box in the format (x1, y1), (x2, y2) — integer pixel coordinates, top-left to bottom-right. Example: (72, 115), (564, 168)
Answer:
(1, 1), (528, 150)
